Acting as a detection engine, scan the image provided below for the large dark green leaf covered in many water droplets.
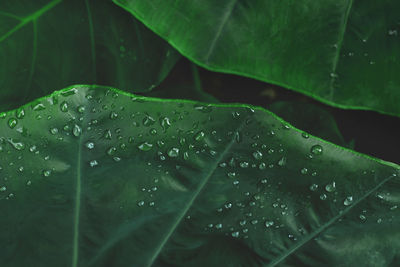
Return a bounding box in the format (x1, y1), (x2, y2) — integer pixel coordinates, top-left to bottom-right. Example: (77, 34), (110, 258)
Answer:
(0, 86), (400, 267)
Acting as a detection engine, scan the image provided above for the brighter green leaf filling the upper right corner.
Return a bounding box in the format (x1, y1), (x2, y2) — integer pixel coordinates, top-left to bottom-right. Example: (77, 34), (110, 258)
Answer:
(114, 0), (400, 115)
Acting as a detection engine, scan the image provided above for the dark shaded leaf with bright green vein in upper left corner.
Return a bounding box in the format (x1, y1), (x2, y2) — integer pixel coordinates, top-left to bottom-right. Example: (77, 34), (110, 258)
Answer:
(0, 0), (178, 110)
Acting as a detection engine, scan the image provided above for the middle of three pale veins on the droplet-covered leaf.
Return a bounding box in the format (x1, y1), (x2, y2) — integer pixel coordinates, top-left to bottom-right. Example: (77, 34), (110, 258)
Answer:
(146, 118), (246, 266)
